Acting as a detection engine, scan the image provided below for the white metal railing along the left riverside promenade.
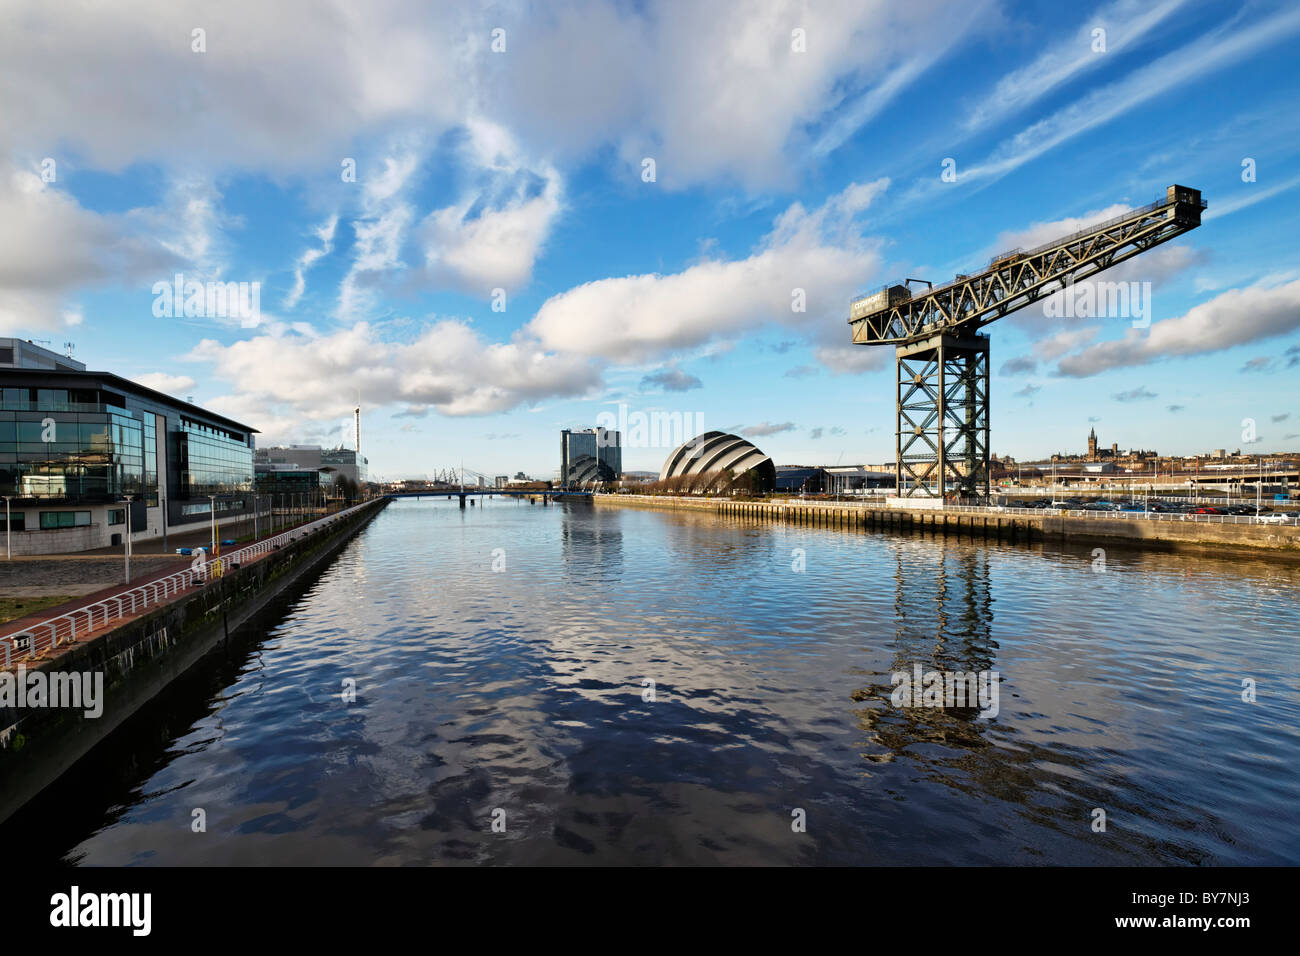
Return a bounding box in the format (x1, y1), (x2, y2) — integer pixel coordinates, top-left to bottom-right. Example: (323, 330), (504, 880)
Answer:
(0, 502), (371, 670)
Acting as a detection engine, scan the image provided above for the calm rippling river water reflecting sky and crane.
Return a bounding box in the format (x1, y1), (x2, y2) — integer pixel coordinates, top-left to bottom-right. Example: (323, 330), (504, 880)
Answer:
(10, 501), (1300, 865)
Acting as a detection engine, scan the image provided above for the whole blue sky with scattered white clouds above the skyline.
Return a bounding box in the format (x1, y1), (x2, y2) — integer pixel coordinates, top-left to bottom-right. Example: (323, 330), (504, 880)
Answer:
(0, 0), (1300, 477)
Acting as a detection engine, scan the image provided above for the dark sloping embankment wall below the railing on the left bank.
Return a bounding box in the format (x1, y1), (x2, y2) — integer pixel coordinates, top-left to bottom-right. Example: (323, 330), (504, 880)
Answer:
(0, 498), (387, 822)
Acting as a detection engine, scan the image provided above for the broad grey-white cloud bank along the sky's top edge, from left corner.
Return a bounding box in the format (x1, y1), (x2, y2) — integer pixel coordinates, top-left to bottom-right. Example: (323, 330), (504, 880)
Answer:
(0, 0), (978, 187)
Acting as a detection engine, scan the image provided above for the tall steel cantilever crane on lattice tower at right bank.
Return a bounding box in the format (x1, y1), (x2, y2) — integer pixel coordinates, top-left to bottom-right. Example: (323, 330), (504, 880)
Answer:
(849, 185), (1206, 498)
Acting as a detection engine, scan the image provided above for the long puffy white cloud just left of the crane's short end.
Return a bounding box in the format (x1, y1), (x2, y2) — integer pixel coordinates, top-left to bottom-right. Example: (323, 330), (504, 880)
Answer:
(525, 179), (888, 363)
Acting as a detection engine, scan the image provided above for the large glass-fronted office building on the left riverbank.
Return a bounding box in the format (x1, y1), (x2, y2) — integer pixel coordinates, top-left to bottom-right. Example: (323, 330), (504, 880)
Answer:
(0, 367), (255, 554)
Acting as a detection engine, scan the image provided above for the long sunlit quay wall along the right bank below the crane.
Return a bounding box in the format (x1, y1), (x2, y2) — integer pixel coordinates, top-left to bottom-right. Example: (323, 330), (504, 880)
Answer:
(593, 494), (1300, 561)
